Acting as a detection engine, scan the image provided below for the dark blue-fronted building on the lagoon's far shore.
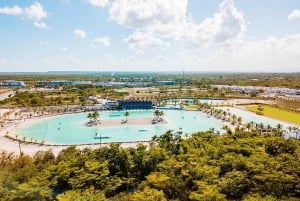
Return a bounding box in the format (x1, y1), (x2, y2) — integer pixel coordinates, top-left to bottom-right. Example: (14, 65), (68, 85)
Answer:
(119, 100), (153, 110)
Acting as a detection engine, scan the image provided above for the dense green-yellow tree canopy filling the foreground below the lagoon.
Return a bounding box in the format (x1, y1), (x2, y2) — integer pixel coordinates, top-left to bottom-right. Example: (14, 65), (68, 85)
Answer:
(0, 130), (300, 201)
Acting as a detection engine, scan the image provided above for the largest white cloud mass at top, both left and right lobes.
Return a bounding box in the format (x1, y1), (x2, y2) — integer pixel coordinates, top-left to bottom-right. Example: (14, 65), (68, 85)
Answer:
(109, 0), (246, 50)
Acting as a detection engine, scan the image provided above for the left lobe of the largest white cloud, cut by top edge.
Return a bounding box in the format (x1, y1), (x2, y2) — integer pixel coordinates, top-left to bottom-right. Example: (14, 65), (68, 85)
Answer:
(109, 0), (187, 37)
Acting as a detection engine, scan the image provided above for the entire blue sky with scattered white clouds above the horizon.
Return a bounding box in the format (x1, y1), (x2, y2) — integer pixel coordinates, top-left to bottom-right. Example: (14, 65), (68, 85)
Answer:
(0, 0), (300, 72)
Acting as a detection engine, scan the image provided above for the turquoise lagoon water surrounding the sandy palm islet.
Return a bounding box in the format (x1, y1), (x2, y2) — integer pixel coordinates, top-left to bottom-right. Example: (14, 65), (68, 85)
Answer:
(12, 110), (223, 145)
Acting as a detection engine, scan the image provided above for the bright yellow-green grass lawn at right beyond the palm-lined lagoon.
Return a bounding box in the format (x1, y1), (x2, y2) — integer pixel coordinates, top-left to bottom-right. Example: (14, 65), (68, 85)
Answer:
(246, 105), (300, 125)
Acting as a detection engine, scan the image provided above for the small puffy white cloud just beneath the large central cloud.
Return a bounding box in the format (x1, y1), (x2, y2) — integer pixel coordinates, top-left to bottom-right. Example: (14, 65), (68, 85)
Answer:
(124, 31), (169, 52)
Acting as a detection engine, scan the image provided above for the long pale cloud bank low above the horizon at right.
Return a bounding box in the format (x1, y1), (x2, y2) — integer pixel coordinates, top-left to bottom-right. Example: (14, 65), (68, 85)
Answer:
(179, 34), (300, 72)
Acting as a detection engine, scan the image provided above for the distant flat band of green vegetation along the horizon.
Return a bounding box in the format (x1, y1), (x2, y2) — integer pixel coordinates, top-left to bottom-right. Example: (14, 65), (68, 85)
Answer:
(0, 72), (300, 88)
